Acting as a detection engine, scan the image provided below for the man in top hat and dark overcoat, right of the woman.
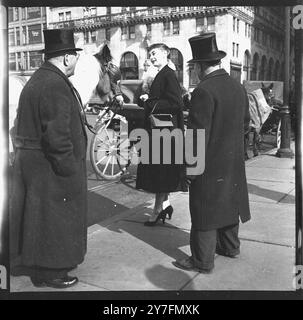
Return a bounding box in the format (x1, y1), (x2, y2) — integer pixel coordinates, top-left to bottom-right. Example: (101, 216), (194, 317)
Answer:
(174, 33), (250, 273)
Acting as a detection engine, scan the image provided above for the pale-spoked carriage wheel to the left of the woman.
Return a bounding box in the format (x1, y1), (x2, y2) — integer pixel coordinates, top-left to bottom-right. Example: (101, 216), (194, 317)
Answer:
(90, 119), (135, 180)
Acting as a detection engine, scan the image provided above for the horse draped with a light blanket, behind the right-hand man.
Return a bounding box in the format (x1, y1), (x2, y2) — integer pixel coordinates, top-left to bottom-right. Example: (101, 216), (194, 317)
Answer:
(244, 82), (276, 160)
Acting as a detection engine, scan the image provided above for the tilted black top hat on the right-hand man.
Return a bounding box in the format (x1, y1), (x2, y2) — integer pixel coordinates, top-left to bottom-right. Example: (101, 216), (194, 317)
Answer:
(188, 32), (226, 63)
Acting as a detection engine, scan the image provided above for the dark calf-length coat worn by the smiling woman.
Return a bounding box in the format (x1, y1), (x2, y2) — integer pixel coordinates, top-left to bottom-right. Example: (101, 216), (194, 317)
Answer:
(136, 65), (186, 193)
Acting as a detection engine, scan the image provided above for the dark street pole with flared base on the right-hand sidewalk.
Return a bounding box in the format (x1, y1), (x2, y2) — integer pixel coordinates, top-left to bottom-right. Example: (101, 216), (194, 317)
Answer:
(276, 7), (294, 158)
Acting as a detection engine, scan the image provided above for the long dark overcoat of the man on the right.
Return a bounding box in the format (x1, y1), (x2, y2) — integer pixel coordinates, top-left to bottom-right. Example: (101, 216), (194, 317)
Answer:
(188, 69), (250, 230)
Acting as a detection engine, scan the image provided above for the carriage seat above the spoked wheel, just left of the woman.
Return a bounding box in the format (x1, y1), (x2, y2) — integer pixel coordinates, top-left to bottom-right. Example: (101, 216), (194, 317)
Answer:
(118, 79), (143, 109)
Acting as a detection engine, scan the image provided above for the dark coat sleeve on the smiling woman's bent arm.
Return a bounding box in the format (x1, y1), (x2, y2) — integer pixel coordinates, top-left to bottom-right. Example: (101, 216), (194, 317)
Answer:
(154, 71), (183, 114)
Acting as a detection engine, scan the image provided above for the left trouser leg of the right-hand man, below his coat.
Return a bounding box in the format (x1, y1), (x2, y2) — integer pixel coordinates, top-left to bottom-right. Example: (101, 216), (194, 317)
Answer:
(190, 228), (217, 270)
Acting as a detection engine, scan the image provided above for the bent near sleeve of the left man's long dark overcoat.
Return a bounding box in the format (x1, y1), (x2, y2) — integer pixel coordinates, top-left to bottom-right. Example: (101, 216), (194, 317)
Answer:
(40, 83), (77, 176)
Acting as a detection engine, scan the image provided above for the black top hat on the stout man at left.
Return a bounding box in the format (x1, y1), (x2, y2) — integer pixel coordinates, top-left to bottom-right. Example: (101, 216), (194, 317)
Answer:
(41, 29), (82, 54)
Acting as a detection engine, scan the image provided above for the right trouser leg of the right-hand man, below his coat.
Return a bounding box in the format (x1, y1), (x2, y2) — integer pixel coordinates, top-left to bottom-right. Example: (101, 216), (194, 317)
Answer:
(216, 224), (240, 256)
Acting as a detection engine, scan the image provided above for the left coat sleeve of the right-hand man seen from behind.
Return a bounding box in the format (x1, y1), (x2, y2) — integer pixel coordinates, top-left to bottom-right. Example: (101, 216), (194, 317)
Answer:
(187, 88), (215, 180)
